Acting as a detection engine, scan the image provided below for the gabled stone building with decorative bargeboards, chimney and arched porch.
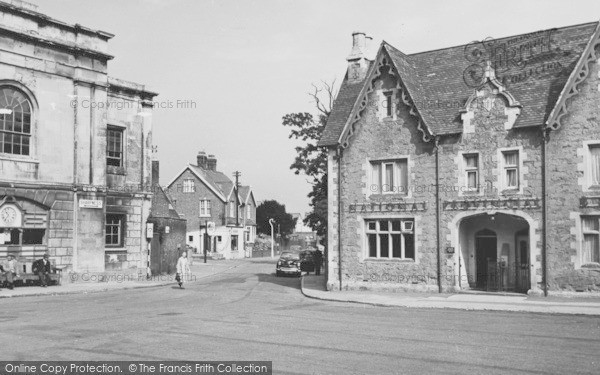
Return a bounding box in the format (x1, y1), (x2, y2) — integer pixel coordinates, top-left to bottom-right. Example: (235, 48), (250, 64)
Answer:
(319, 23), (600, 293)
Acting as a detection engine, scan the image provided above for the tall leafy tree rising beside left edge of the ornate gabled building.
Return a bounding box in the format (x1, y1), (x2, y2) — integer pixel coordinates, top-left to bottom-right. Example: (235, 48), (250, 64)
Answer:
(282, 81), (335, 245)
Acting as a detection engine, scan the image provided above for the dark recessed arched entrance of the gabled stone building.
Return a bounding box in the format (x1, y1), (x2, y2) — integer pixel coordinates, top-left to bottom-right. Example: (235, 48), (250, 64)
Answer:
(458, 211), (531, 293)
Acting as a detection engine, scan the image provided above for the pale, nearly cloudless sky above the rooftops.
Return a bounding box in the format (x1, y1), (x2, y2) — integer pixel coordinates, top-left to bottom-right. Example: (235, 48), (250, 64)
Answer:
(29, 0), (600, 214)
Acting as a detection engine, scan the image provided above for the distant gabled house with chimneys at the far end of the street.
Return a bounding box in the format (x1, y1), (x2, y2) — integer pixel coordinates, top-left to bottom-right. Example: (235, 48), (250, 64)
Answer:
(167, 151), (256, 259)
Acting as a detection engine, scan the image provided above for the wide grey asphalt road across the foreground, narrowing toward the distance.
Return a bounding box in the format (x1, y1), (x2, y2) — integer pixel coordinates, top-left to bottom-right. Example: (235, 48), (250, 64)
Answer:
(0, 259), (600, 374)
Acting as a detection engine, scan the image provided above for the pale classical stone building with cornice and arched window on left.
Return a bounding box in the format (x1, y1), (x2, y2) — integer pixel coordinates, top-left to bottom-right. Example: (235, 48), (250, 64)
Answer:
(0, 0), (156, 272)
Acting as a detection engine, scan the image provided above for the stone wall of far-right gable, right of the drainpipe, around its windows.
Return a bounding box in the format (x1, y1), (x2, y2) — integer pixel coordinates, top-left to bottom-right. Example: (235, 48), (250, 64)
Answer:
(547, 55), (600, 291)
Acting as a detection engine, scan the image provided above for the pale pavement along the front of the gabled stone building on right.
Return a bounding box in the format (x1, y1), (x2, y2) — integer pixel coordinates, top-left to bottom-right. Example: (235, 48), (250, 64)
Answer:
(301, 275), (600, 316)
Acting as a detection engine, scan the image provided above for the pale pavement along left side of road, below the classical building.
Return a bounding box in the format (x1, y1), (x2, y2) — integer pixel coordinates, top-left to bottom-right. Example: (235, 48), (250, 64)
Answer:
(0, 260), (243, 298)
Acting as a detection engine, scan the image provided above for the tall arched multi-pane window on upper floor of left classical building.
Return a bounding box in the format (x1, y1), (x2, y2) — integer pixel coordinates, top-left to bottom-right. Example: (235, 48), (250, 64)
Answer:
(0, 86), (31, 155)
